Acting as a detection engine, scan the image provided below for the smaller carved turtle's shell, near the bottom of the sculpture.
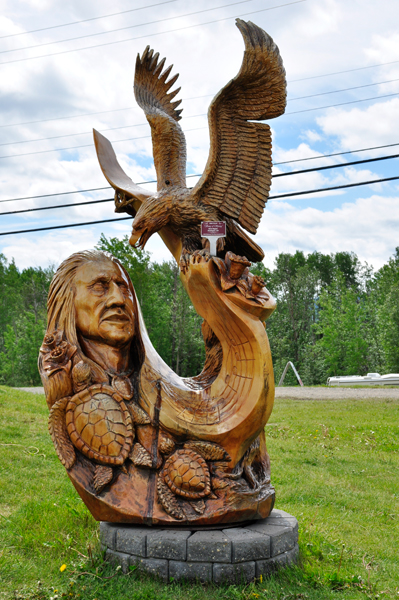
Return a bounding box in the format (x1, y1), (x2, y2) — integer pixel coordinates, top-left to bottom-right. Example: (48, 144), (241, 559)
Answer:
(163, 448), (211, 500)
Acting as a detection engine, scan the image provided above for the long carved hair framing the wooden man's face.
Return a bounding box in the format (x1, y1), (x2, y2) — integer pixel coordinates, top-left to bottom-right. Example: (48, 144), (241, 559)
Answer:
(39, 250), (145, 405)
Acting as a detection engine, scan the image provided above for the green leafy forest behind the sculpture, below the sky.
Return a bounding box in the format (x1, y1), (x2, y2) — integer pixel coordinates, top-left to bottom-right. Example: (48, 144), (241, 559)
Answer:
(0, 235), (399, 386)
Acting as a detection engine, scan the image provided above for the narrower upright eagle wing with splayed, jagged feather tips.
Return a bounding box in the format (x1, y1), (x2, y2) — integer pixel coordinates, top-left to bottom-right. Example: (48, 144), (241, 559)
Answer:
(134, 46), (186, 190)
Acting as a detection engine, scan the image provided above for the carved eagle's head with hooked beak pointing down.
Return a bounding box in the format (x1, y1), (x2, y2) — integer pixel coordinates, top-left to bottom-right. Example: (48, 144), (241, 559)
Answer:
(129, 196), (171, 250)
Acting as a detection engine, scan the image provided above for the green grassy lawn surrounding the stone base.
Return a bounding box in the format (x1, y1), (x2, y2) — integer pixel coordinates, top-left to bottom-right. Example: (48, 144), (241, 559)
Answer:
(0, 387), (399, 600)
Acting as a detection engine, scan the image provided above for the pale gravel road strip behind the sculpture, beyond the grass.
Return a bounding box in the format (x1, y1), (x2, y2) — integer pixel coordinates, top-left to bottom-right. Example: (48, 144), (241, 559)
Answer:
(16, 386), (399, 400)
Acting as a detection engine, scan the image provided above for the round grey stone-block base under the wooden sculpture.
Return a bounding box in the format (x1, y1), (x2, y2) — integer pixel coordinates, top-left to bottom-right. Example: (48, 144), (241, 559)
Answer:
(100, 509), (298, 584)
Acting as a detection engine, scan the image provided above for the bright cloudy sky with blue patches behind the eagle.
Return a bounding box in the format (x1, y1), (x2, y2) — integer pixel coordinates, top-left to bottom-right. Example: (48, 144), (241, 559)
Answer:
(0, 0), (399, 269)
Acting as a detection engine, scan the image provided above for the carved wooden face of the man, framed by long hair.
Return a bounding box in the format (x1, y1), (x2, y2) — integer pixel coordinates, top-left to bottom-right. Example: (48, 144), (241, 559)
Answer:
(74, 260), (134, 347)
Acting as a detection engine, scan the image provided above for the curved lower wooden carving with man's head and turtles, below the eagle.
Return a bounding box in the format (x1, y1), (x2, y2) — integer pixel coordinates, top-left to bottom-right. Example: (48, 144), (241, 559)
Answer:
(41, 251), (275, 525)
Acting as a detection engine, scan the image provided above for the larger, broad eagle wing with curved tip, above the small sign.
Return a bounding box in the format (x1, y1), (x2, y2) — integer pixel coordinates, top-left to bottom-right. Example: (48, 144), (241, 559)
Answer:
(193, 19), (286, 233)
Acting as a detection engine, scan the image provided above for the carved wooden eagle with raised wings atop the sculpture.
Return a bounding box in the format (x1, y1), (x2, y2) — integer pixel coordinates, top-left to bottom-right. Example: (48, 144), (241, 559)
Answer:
(94, 19), (286, 262)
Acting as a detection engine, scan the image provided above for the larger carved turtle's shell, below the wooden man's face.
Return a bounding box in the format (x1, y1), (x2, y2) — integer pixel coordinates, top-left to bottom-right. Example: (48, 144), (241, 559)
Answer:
(66, 384), (134, 466)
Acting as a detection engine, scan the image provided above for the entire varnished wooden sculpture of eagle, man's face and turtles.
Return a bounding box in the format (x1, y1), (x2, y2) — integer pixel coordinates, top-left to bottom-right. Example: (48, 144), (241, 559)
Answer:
(39, 20), (285, 526)
